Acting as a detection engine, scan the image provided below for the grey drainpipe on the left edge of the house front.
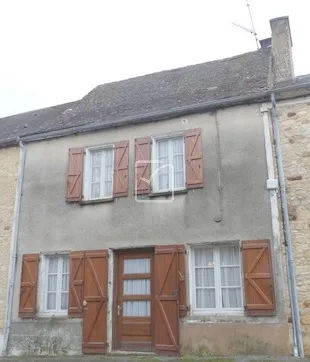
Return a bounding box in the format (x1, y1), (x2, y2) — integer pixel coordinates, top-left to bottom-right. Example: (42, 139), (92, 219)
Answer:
(2, 141), (26, 355)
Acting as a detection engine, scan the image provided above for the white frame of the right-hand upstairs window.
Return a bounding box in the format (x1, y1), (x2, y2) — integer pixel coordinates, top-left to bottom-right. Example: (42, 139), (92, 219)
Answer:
(151, 132), (186, 193)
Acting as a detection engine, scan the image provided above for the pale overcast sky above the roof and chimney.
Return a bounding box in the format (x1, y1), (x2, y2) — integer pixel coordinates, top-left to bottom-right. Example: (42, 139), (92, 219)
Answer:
(0, 0), (310, 117)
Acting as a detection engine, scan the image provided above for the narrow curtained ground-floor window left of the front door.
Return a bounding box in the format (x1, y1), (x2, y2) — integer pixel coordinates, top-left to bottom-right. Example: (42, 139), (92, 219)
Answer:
(43, 255), (69, 314)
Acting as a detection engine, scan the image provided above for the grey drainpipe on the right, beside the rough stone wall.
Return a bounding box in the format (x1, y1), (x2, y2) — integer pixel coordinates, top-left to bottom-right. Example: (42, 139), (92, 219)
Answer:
(271, 93), (304, 358)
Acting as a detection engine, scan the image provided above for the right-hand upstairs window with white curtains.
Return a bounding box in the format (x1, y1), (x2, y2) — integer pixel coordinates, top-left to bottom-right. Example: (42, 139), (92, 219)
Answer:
(152, 136), (185, 192)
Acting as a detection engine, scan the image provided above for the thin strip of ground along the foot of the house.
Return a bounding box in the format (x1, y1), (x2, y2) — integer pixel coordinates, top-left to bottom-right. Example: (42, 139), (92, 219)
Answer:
(0, 355), (310, 362)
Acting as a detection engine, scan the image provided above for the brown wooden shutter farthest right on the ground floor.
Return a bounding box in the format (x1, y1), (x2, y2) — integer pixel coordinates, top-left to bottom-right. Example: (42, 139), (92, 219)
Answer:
(242, 240), (275, 316)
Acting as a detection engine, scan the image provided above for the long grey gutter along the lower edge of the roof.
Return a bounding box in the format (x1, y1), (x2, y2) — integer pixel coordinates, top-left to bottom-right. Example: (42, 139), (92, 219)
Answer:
(0, 82), (310, 148)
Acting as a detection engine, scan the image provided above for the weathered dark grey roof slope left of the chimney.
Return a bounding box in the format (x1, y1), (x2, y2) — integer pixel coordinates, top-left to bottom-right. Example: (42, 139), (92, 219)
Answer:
(0, 49), (271, 139)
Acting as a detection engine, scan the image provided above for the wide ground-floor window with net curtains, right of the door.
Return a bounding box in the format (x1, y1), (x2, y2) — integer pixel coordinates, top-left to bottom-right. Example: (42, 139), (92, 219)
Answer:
(192, 245), (243, 313)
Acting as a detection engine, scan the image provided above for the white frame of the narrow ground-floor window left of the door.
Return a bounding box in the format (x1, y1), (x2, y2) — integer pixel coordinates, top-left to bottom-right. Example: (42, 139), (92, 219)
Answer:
(37, 251), (70, 317)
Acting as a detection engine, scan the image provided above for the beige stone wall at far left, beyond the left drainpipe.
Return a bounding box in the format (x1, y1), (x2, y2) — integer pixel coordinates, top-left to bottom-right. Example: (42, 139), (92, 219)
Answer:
(0, 147), (19, 353)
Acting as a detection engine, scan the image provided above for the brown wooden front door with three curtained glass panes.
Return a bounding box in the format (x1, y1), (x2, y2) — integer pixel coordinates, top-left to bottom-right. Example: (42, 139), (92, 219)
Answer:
(115, 250), (153, 352)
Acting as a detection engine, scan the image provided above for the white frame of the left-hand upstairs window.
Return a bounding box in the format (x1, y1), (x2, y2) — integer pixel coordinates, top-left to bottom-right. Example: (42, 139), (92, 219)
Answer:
(83, 144), (115, 201)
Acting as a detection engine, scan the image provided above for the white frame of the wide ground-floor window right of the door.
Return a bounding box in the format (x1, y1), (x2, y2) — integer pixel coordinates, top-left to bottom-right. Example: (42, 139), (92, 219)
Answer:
(189, 242), (244, 316)
